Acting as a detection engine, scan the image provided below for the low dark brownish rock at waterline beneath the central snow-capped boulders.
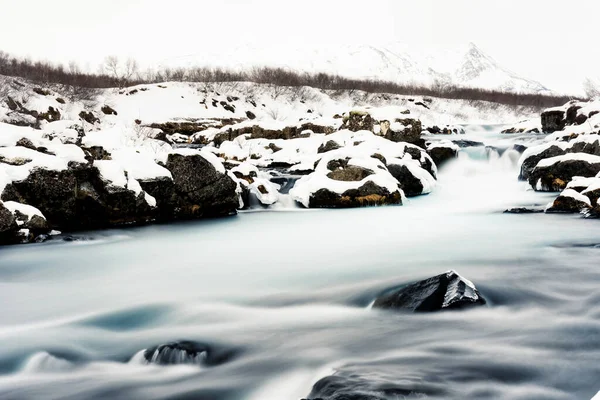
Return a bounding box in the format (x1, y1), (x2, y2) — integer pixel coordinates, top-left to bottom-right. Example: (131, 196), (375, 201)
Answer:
(309, 181), (402, 208)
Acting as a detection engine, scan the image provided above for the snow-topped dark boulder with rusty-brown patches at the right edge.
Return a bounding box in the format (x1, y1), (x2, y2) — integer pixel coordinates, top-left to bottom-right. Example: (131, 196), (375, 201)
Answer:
(528, 153), (600, 192)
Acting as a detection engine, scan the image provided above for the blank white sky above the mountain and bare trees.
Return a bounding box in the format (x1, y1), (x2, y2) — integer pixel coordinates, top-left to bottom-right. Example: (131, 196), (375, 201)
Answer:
(0, 0), (600, 92)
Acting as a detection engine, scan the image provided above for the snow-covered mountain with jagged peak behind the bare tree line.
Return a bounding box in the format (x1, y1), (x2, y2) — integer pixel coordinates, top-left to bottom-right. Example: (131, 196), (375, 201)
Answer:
(161, 43), (549, 93)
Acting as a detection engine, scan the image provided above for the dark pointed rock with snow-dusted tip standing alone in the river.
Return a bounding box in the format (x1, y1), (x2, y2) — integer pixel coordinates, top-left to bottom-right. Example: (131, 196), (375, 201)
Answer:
(373, 271), (486, 312)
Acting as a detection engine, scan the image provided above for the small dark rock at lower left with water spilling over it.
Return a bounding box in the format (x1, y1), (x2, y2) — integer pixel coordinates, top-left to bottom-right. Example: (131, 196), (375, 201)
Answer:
(144, 341), (240, 367)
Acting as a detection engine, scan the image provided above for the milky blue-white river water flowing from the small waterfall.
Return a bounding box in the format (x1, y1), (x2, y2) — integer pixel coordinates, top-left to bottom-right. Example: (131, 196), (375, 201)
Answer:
(0, 127), (600, 400)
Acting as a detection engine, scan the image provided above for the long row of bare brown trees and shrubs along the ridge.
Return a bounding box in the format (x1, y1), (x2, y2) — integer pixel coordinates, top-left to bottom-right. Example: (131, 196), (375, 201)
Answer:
(0, 51), (573, 108)
